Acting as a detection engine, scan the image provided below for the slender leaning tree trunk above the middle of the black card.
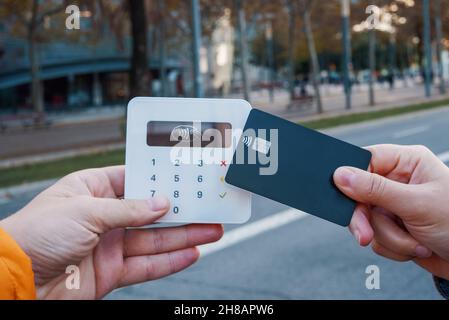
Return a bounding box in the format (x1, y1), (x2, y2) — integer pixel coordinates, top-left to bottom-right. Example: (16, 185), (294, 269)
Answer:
(303, 8), (323, 113)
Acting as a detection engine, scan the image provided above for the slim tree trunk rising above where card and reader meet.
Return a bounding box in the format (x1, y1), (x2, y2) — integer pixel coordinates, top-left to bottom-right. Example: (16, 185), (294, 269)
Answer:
(236, 0), (251, 101)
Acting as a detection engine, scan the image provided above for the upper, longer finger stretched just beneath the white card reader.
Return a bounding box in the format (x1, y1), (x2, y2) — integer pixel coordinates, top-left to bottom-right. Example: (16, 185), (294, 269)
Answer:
(124, 224), (223, 257)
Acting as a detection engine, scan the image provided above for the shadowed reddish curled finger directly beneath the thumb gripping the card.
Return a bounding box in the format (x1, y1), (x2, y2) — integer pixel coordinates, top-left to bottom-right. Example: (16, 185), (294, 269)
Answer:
(371, 209), (432, 258)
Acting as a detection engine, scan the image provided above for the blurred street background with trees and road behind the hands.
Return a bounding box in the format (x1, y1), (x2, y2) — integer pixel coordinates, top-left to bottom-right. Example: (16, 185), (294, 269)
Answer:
(0, 0), (449, 299)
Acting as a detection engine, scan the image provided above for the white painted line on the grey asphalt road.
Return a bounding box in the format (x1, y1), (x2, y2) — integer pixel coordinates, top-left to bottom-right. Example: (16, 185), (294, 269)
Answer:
(199, 151), (449, 257)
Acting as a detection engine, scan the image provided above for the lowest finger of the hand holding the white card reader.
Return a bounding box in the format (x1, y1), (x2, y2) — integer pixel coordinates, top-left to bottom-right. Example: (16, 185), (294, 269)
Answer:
(119, 248), (199, 287)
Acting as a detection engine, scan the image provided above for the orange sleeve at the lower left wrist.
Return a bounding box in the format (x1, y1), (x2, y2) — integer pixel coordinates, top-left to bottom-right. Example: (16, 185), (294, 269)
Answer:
(0, 228), (36, 300)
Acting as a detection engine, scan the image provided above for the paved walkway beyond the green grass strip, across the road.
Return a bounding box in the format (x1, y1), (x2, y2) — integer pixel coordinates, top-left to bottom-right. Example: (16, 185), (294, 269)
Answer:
(0, 84), (449, 169)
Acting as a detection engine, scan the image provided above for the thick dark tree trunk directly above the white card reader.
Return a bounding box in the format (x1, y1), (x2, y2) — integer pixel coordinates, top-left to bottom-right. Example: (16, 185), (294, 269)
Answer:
(129, 0), (151, 98)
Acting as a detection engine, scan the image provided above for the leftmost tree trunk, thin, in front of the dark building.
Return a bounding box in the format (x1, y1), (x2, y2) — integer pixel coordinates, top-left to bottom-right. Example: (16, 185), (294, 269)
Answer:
(28, 0), (44, 113)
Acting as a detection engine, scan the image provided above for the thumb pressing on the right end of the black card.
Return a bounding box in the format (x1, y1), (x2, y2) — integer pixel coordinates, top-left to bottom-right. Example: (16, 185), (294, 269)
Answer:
(334, 167), (417, 216)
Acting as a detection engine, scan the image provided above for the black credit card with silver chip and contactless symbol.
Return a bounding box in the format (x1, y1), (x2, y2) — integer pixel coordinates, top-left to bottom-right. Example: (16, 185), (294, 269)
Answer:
(225, 109), (371, 226)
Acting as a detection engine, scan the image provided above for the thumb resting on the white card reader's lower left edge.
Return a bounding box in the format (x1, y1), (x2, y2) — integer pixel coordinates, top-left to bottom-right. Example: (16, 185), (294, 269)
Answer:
(83, 197), (170, 233)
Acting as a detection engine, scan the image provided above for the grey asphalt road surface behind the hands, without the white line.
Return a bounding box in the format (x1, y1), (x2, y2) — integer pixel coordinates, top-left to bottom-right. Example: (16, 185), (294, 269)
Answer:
(0, 108), (449, 300)
